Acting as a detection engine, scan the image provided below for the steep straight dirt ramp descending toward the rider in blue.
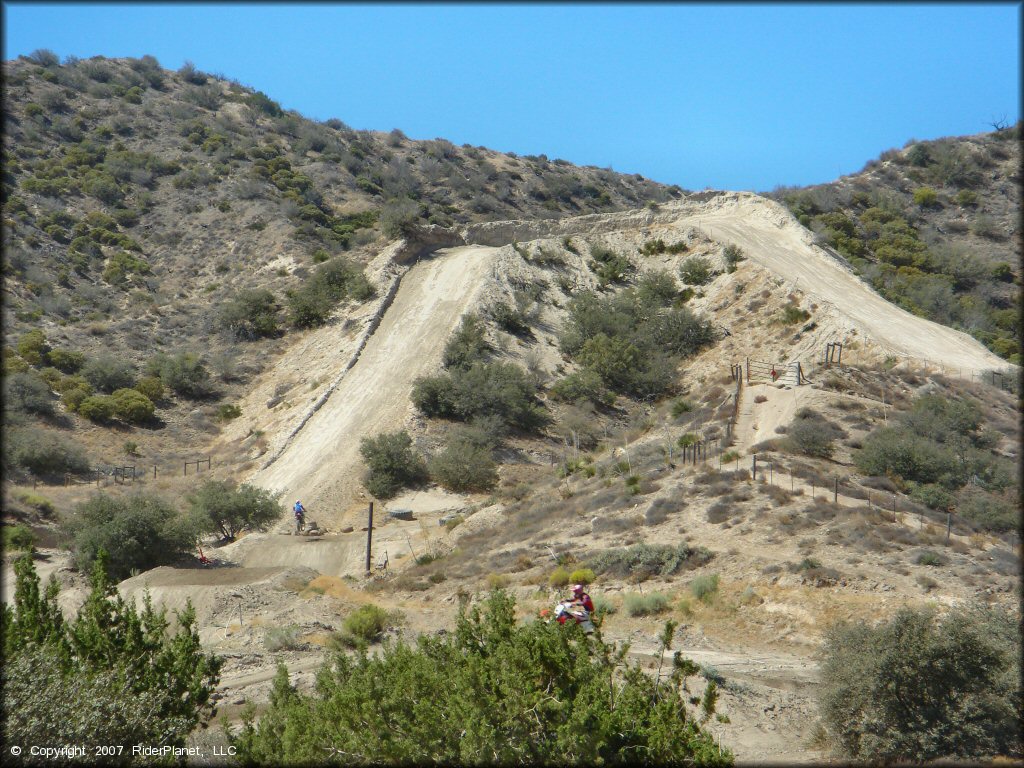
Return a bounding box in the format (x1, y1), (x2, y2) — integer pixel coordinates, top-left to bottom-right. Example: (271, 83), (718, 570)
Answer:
(252, 246), (496, 525)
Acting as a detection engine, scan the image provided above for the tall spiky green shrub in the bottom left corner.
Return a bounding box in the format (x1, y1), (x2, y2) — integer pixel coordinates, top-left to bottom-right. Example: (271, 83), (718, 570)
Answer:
(0, 557), (221, 749)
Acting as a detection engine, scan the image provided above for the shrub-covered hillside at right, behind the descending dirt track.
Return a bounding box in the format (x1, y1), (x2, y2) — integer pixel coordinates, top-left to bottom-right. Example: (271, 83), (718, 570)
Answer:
(773, 125), (1021, 364)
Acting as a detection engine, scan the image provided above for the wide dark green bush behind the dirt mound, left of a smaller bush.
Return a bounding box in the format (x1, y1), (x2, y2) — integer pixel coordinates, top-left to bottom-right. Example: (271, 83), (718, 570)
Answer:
(69, 493), (197, 580)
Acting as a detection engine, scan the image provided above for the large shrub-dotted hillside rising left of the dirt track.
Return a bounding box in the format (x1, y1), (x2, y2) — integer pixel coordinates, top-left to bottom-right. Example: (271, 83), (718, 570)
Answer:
(3, 54), (681, 475)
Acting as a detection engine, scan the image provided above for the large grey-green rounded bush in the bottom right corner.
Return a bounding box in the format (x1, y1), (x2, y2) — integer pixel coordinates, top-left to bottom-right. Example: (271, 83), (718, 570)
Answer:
(819, 606), (1024, 764)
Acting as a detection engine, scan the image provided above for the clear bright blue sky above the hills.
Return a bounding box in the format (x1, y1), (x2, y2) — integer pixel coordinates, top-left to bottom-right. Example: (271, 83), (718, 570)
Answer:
(3, 2), (1021, 191)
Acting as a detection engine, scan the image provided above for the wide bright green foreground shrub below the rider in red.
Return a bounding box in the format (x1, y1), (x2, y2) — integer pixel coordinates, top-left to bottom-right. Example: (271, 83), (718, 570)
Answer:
(231, 590), (732, 766)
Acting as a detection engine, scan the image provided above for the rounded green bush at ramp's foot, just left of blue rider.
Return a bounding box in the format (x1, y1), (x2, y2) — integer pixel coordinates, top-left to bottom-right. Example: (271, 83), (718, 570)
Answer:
(188, 480), (282, 539)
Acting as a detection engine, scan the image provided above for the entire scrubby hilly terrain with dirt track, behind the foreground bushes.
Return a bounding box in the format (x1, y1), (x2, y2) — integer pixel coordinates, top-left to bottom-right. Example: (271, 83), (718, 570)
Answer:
(4, 53), (1021, 763)
